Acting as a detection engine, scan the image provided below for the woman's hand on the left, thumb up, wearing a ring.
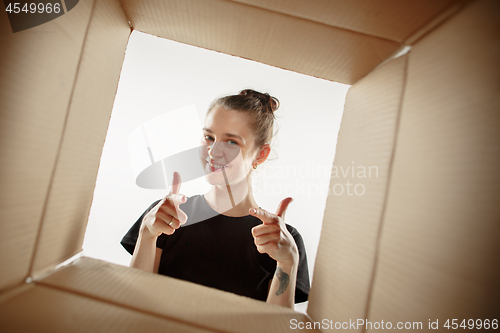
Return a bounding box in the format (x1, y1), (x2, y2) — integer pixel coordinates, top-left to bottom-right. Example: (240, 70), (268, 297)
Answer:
(140, 172), (187, 238)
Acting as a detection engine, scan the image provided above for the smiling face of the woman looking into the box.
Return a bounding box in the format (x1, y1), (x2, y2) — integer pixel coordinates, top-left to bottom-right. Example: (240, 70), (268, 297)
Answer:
(200, 106), (256, 185)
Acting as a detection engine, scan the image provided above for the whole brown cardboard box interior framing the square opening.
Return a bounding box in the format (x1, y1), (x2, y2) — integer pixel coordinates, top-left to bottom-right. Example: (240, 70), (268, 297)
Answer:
(0, 0), (500, 332)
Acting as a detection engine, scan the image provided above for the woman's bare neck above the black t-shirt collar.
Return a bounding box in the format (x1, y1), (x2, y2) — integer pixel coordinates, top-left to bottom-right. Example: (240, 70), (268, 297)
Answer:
(205, 175), (259, 217)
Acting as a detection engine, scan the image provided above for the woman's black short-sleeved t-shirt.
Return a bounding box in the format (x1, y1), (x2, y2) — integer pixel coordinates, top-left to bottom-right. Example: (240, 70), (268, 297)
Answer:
(121, 195), (309, 303)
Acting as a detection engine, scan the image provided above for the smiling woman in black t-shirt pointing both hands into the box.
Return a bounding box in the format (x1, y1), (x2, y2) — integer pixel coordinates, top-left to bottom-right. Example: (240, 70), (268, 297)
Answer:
(122, 90), (309, 309)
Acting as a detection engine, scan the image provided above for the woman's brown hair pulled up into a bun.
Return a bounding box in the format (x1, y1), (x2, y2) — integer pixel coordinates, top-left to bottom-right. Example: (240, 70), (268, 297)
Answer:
(207, 89), (280, 147)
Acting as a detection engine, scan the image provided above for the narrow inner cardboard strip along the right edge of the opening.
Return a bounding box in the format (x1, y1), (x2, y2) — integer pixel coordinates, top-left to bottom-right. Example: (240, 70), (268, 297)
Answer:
(308, 55), (407, 332)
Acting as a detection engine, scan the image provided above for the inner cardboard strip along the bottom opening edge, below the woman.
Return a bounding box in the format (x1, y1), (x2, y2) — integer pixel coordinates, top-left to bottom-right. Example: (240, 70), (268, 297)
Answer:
(37, 257), (316, 333)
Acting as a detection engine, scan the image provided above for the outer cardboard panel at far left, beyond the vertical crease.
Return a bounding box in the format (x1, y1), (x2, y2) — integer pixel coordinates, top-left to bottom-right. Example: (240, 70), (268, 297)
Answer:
(0, 1), (92, 290)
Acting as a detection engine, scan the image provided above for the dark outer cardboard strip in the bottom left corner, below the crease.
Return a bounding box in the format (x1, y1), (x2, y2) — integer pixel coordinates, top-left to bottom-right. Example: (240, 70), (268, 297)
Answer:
(0, 286), (213, 333)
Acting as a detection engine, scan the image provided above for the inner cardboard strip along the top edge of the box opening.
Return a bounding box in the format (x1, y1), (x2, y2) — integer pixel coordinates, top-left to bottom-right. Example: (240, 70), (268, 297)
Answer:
(121, 0), (401, 84)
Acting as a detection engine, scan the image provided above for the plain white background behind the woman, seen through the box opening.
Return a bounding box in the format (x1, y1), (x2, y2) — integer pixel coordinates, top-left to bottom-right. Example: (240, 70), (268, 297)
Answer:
(83, 31), (349, 311)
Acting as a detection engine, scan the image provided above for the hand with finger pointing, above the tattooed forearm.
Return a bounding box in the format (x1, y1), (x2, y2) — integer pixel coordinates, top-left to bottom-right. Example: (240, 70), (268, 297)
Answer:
(250, 198), (299, 266)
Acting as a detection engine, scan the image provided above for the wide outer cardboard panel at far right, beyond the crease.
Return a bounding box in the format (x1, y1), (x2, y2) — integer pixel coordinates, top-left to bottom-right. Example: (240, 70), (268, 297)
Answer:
(368, 0), (500, 328)
